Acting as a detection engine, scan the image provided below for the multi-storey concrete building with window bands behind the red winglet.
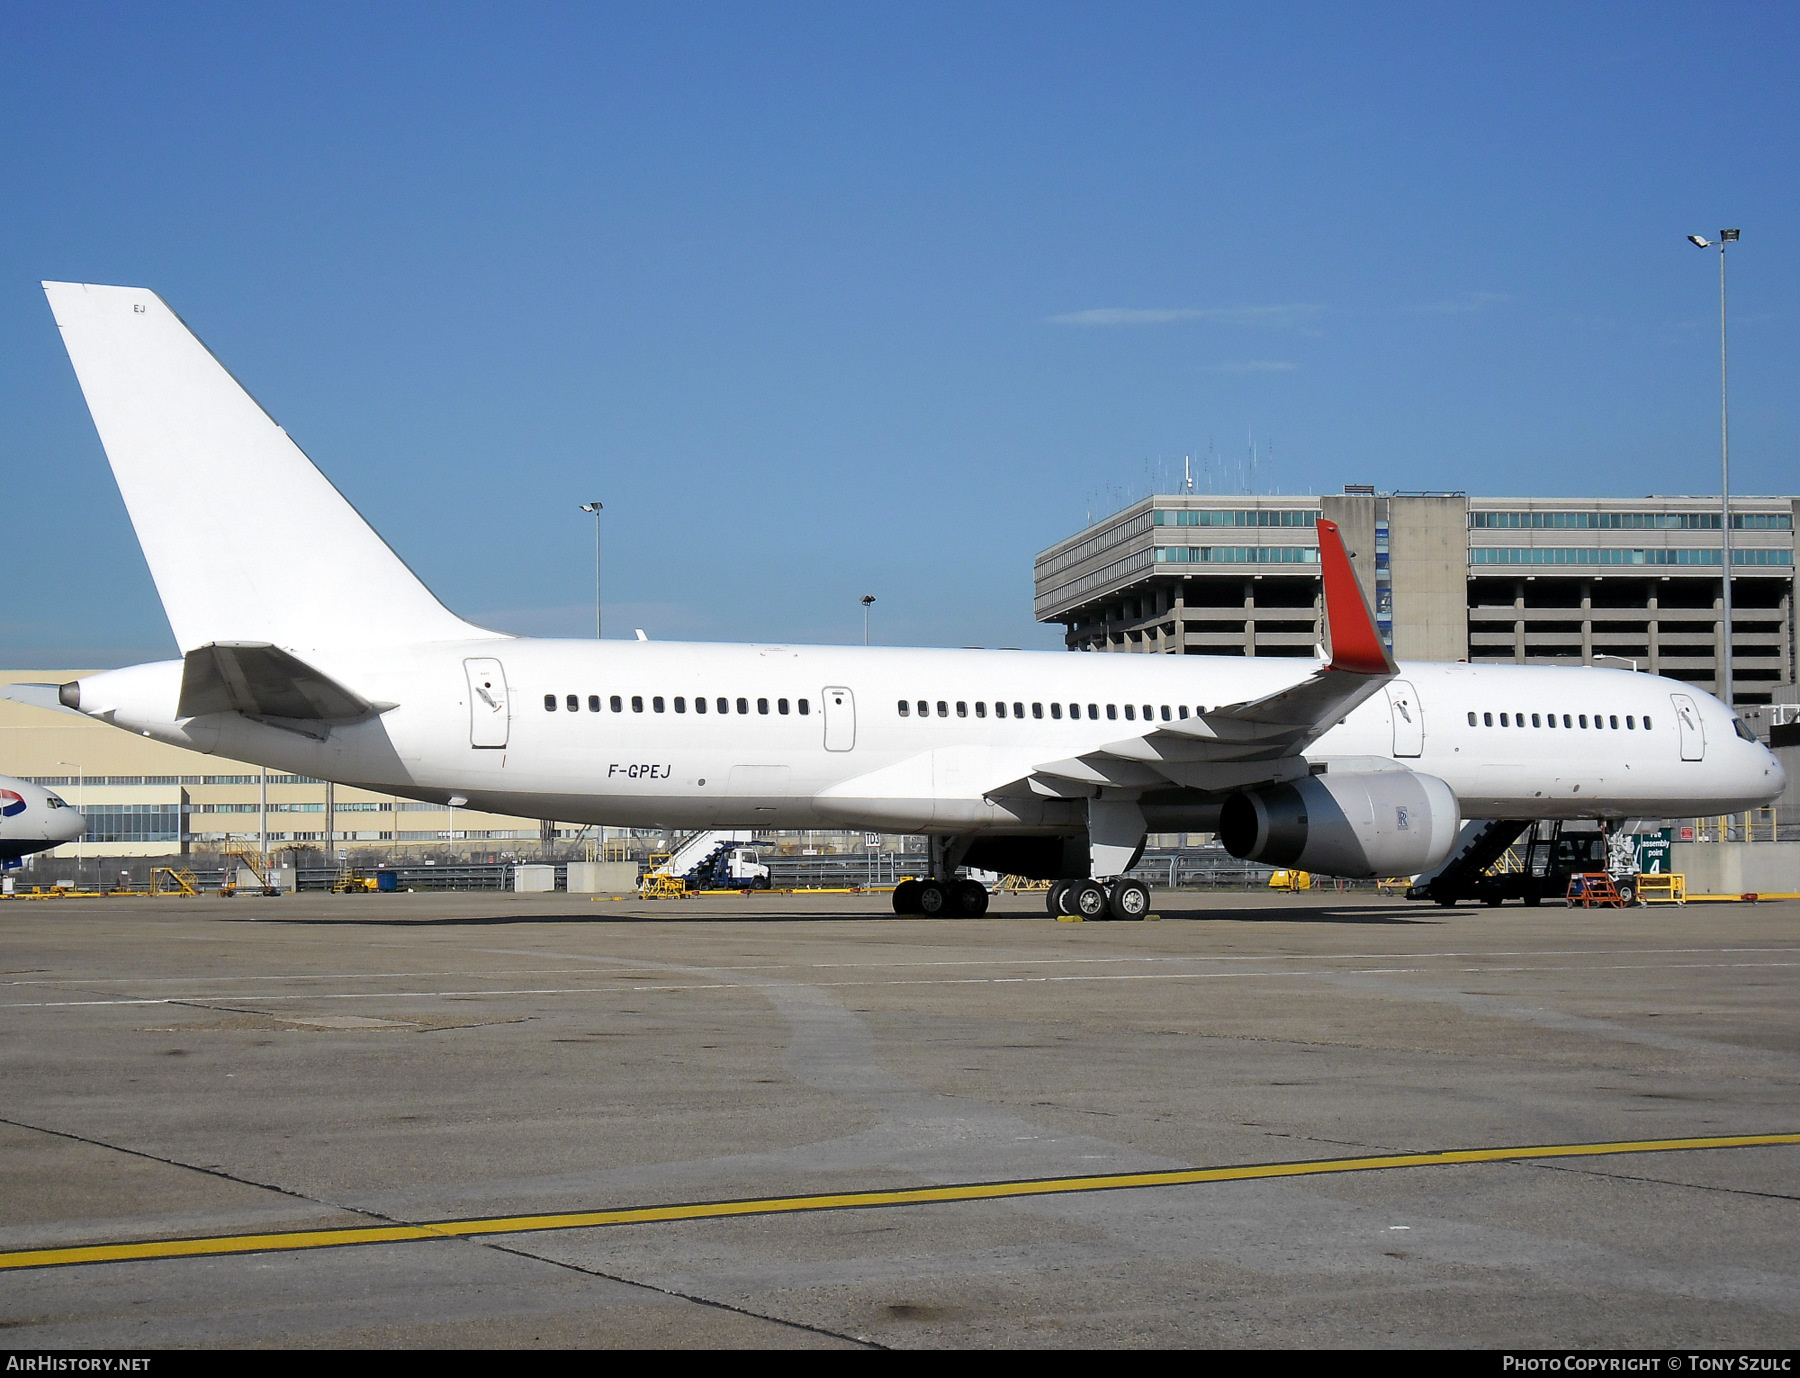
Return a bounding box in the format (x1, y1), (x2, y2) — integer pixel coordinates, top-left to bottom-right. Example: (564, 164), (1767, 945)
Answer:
(1033, 484), (1800, 703)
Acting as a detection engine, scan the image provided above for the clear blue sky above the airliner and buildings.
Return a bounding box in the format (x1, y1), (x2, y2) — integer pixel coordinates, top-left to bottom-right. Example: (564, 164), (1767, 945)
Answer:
(0, 4), (1800, 667)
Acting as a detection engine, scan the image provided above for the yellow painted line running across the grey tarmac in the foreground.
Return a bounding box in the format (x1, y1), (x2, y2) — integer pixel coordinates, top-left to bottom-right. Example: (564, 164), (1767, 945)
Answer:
(0, 1133), (1800, 1270)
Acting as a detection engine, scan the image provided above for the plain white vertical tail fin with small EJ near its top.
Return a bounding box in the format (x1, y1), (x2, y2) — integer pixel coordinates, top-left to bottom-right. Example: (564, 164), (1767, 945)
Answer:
(43, 282), (493, 653)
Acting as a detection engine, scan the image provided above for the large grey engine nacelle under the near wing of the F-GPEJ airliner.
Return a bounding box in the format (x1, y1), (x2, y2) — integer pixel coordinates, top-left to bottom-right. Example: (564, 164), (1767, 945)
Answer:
(1219, 768), (1460, 876)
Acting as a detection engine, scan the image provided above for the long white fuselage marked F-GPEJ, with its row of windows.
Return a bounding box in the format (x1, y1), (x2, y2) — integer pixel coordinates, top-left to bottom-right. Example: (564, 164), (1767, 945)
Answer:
(81, 639), (1786, 833)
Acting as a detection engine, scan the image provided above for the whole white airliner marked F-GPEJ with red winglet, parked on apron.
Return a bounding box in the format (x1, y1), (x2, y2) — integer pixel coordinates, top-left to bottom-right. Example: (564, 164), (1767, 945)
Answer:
(31, 282), (1784, 917)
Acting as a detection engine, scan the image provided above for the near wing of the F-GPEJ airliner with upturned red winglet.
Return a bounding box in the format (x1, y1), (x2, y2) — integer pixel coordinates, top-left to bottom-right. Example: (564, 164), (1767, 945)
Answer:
(994, 520), (1399, 797)
